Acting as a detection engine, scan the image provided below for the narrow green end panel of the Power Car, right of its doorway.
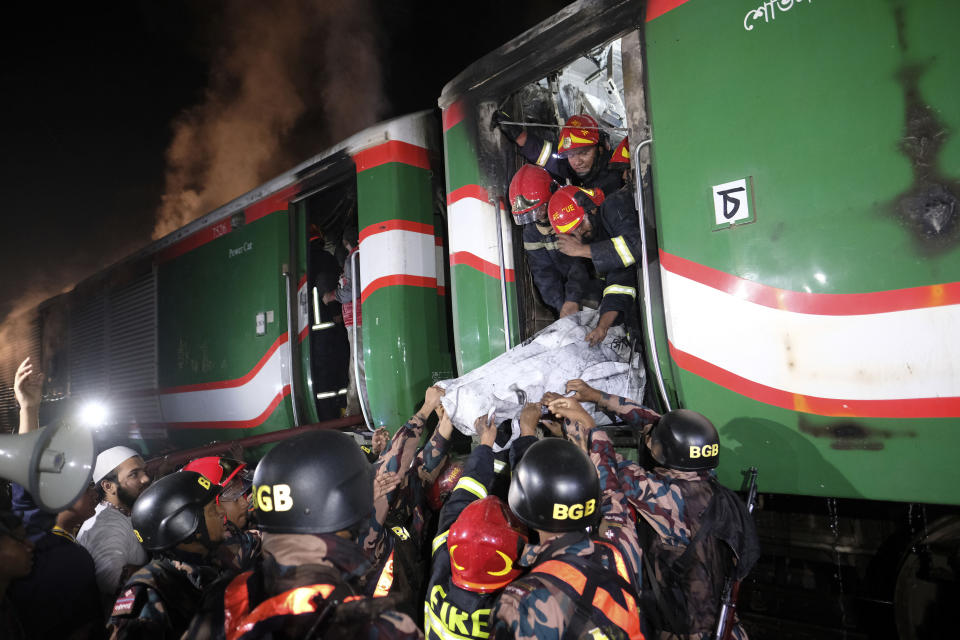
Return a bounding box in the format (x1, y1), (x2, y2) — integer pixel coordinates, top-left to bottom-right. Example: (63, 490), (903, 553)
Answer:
(357, 156), (453, 432)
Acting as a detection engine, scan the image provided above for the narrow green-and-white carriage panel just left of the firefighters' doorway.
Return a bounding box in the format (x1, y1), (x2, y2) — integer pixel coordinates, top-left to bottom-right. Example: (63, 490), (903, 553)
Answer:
(443, 104), (519, 375)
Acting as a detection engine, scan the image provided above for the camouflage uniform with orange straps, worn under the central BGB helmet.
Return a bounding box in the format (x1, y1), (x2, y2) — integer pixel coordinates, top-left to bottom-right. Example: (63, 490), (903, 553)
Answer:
(491, 431), (644, 640)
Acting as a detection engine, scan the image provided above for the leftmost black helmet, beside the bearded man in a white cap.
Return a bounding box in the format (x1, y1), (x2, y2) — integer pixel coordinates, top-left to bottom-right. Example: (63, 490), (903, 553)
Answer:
(131, 471), (221, 551)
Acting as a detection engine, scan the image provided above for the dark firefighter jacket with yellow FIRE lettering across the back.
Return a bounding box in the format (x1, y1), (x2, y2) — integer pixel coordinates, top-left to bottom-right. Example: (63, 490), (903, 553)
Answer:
(423, 436), (537, 640)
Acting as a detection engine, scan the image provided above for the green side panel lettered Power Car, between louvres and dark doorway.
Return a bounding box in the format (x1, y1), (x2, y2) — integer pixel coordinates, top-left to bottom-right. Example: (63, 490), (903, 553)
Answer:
(157, 211), (293, 447)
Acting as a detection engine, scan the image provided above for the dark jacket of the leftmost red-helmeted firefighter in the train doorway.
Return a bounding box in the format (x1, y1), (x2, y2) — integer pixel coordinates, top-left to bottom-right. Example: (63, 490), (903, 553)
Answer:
(523, 223), (590, 312)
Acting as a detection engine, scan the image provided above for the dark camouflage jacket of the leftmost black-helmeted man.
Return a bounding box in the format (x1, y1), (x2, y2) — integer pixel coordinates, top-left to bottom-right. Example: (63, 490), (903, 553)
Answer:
(107, 549), (220, 640)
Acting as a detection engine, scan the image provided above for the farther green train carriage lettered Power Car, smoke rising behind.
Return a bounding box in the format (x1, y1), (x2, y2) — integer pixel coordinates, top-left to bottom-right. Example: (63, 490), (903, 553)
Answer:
(6, 112), (453, 453)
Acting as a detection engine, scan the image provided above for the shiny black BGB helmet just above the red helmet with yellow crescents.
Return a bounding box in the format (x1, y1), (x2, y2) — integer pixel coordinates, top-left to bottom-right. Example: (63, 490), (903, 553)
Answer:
(508, 438), (600, 532)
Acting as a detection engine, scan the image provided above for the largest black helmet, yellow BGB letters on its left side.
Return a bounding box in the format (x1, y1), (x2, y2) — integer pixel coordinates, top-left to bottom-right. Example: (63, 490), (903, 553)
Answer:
(253, 431), (373, 533)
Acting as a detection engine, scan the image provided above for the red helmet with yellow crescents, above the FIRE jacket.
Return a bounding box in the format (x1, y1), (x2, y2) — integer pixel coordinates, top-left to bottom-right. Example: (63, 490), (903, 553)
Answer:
(447, 496), (527, 593)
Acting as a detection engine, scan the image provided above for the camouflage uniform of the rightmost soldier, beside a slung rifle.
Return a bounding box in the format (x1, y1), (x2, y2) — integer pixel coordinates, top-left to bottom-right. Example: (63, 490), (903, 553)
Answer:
(601, 394), (758, 640)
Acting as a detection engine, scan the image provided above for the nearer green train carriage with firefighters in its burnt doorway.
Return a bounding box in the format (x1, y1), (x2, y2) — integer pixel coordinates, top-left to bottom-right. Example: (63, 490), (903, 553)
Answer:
(440, 0), (960, 637)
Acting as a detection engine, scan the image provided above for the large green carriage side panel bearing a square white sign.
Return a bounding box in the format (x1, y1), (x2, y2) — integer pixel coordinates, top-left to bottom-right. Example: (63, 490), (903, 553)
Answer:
(646, 0), (960, 504)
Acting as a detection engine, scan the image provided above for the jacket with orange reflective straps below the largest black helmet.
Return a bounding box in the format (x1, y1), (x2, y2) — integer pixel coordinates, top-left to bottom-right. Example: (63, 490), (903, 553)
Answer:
(184, 533), (423, 640)
